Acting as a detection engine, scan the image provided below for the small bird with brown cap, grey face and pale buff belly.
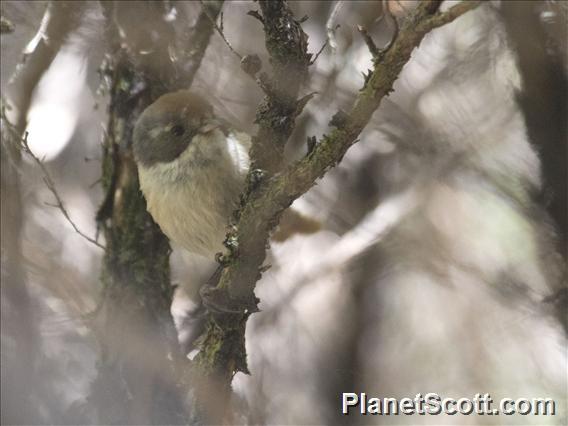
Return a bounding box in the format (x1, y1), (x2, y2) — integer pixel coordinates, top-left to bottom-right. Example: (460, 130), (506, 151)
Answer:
(133, 90), (251, 258)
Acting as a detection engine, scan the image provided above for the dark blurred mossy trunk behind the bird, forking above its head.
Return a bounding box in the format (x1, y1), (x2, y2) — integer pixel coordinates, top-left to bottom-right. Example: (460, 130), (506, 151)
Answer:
(90, 1), (222, 424)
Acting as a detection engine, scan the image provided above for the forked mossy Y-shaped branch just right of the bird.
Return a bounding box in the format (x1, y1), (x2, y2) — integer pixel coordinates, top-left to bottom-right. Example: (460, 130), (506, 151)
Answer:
(193, 0), (479, 422)
